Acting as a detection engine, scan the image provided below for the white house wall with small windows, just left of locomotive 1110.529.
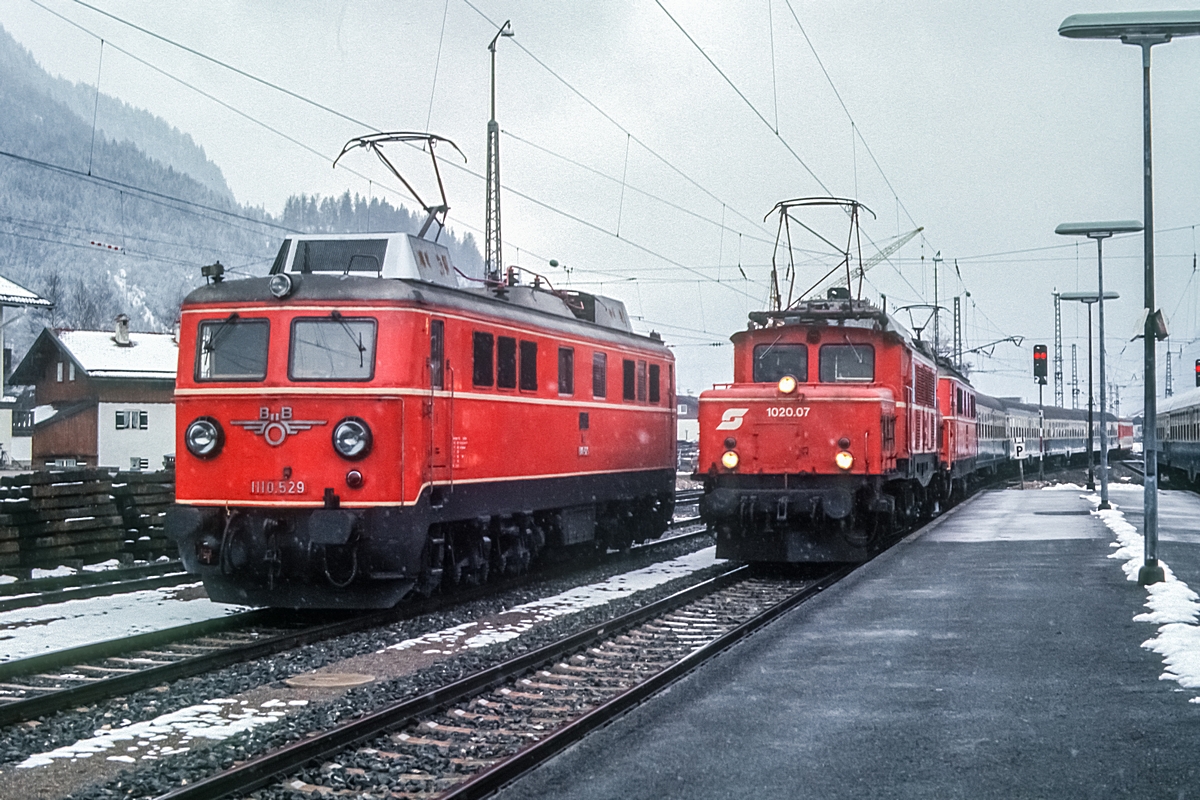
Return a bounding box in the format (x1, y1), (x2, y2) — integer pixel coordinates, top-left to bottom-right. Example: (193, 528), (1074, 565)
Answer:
(96, 403), (175, 471)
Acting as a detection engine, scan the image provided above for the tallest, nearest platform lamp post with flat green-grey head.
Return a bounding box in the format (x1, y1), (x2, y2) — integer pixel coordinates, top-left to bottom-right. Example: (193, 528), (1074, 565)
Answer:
(1058, 11), (1200, 587)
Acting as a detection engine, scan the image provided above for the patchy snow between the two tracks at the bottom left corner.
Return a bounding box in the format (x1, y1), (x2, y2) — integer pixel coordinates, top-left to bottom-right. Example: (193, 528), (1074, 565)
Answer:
(17, 698), (308, 769)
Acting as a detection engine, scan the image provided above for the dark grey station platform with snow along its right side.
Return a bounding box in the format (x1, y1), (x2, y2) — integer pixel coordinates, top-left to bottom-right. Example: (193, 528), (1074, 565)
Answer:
(499, 486), (1200, 800)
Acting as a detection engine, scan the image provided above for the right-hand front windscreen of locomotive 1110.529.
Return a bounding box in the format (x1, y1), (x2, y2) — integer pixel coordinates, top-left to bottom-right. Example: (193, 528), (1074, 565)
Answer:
(288, 312), (376, 380)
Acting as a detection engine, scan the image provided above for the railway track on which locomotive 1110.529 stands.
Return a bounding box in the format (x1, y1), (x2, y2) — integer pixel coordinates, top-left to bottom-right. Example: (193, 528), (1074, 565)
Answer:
(0, 517), (706, 727)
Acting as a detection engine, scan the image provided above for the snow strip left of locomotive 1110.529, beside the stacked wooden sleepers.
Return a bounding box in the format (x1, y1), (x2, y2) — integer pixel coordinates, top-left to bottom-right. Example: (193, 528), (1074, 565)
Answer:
(0, 583), (244, 662)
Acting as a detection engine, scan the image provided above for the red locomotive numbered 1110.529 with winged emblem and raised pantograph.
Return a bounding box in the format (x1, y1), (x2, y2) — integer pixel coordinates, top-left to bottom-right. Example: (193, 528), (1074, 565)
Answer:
(167, 133), (676, 608)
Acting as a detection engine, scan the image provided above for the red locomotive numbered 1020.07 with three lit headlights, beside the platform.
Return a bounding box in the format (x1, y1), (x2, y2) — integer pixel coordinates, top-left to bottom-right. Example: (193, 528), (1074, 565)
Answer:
(697, 288), (977, 561)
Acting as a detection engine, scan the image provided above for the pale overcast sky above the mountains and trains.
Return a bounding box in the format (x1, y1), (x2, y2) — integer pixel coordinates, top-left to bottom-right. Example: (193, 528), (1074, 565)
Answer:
(0, 0), (1200, 411)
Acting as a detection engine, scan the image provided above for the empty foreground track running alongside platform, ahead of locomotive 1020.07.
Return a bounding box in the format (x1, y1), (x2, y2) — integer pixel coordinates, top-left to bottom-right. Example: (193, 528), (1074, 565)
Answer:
(150, 566), (853, 800)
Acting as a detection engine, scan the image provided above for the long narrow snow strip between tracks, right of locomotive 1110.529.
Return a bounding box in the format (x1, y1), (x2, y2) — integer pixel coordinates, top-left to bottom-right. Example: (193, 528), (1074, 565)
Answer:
(388, 547), (724, 654)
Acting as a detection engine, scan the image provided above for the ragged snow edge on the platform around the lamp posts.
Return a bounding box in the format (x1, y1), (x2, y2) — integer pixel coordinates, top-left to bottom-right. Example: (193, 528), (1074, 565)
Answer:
(1082, 487), (1200, 703)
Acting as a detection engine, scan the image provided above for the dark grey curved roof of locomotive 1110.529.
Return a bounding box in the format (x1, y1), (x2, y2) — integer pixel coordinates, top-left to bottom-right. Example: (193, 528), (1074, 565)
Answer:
(184, 273), (665, 348)
